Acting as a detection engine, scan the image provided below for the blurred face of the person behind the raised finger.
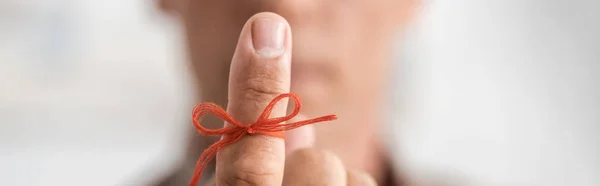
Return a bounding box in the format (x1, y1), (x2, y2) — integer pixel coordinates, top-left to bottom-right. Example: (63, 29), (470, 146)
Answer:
(163, 0), (415, 181)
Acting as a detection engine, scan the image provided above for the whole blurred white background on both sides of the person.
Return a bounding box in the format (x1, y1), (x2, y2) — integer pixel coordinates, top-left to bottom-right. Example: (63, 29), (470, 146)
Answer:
(0, 0), (600, 186)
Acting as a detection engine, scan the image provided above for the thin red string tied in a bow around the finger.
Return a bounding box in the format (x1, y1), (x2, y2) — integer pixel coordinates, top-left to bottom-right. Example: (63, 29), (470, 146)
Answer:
(190, 93), (337, 186)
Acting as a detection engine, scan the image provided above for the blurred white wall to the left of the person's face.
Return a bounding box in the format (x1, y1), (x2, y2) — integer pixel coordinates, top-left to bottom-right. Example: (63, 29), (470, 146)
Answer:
(0, 0), (193, 186)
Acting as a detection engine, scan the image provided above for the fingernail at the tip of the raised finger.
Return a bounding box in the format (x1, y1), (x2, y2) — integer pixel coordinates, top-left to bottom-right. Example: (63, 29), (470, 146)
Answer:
(252, 19), (285, 58)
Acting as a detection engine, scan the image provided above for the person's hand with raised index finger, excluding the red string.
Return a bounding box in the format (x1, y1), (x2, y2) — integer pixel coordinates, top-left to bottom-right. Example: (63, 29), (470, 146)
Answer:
(197, 13), (376, 186)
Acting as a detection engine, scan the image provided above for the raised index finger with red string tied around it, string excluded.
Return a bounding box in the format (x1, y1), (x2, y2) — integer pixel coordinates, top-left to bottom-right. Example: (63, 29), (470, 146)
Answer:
(216, 13), (291, 186)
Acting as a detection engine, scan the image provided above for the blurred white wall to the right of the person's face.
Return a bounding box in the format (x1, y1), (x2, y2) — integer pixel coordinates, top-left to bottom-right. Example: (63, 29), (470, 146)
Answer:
(394, 0), (600, 186)
